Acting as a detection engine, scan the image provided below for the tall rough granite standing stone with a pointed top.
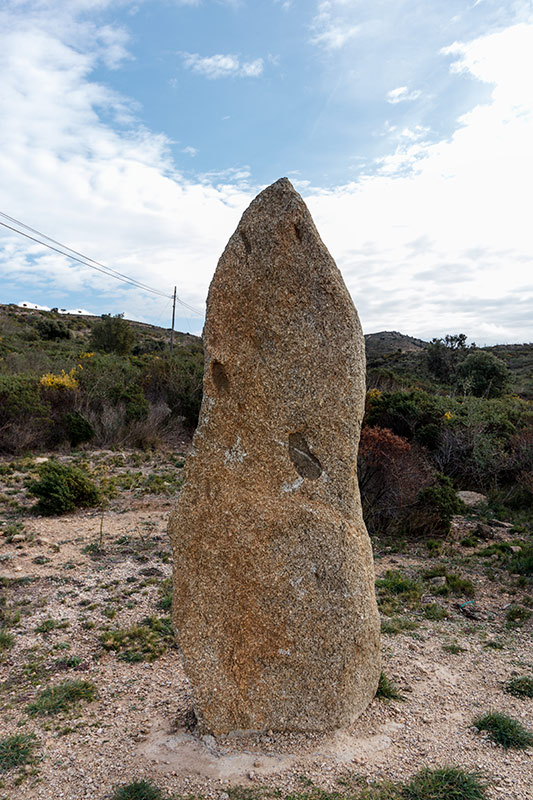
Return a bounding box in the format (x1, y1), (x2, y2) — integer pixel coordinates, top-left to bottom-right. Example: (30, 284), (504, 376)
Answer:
(169, 178), (380, 734)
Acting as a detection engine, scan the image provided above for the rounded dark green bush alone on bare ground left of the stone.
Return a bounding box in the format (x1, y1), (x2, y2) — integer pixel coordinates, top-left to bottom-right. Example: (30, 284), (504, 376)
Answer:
(28, 461), (100, 516)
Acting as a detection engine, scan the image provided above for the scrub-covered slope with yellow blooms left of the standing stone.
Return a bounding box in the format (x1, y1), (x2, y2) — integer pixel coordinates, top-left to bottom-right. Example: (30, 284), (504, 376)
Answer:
(0, 306), (203, 454)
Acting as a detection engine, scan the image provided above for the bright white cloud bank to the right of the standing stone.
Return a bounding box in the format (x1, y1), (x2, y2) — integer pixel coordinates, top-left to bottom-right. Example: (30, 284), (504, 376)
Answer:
(302, 24), (533, 342)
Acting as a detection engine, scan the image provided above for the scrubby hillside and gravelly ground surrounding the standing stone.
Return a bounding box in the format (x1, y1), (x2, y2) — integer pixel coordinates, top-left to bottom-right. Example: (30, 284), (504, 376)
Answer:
(0, 308), (533, 800)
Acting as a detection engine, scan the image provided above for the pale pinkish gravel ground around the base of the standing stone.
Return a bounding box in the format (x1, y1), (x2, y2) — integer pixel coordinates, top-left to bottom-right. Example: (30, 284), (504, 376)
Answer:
(0, 476), (533, 800)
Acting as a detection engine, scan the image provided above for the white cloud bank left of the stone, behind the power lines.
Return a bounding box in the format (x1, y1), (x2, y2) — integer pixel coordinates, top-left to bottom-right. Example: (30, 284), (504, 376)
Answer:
(0, 6), (249, 324)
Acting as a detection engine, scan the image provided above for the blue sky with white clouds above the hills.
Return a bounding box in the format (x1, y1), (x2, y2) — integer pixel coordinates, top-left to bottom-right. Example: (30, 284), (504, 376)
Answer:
(0, 0), (533, 345)
